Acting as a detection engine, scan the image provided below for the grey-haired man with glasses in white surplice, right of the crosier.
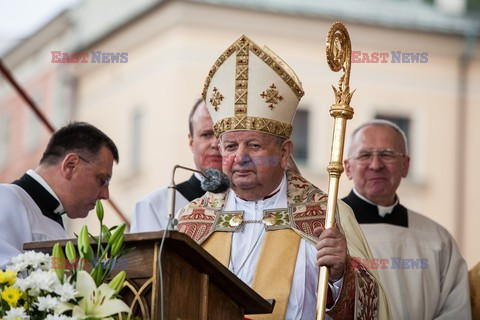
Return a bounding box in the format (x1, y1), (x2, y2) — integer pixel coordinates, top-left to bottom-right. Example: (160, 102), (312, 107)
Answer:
(343, 120), (471, 320)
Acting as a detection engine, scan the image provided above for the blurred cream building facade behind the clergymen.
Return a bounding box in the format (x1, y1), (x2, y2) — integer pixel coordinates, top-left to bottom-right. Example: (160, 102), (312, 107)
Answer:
(0, 0), (480, 266)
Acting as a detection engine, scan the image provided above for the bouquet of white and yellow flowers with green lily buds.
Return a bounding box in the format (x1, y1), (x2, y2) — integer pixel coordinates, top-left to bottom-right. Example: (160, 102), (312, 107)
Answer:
(0, 201), (130, 320)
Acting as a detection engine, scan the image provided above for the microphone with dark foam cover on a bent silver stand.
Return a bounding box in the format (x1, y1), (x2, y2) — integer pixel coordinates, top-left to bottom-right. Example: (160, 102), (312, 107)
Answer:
(167, 164), (230, 230)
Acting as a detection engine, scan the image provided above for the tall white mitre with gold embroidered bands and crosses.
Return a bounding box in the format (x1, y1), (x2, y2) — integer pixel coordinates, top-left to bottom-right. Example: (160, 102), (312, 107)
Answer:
(202, 35), (304, 139)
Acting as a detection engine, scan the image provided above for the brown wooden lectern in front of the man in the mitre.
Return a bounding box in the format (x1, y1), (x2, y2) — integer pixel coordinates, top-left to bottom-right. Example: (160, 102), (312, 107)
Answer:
(24, 231), (275, 320)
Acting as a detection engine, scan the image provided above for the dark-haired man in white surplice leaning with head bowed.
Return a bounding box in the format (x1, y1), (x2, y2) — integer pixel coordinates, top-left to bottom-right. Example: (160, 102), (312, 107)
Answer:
(0, 122), (118, 269)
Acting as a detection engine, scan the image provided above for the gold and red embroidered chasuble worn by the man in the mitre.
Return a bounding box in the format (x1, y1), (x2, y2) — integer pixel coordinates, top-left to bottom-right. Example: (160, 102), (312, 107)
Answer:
(178, 171), (390, 319)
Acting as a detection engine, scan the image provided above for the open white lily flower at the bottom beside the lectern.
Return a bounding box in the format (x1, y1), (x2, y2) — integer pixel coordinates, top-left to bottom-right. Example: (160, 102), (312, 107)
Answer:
(55, 270), (130, 319)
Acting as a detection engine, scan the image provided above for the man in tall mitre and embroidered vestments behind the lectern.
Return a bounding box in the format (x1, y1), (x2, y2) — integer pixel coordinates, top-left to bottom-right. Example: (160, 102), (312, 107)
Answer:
(178, 36), (389, 319)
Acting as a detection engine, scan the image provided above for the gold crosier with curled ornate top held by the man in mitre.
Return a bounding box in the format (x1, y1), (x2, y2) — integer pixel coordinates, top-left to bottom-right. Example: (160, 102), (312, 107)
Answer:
(317, 22), (355, 320)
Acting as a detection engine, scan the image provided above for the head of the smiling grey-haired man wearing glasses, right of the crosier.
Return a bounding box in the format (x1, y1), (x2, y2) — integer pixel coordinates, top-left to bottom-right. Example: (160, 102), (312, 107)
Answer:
(344, 126), (410, 206)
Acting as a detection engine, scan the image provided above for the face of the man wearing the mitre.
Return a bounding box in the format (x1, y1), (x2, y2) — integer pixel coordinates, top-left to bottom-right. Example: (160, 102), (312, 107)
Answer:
(220, 131), (292, 200)
